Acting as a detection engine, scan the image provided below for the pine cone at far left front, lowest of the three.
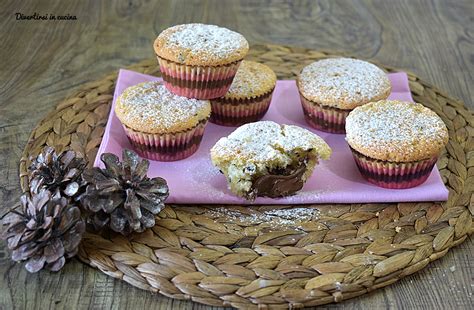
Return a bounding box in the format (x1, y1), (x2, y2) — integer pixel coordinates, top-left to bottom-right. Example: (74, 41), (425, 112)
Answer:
(2, 189), (85, 272)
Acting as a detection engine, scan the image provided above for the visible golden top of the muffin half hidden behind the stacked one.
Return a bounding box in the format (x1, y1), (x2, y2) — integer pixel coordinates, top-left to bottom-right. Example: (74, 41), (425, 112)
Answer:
(224, 60), (276, 99)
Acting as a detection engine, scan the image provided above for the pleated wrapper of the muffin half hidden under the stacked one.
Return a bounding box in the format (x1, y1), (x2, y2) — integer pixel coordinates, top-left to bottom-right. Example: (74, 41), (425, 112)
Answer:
(210, 90), (273, 126)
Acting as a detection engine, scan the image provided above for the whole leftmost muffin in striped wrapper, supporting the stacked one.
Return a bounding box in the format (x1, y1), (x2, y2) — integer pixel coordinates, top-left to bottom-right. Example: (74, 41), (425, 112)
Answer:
(115, 82), (211, 161)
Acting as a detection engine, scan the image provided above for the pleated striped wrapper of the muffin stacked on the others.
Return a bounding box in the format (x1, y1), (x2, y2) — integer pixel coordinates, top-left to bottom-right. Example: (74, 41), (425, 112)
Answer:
(157, 56), (241, 99)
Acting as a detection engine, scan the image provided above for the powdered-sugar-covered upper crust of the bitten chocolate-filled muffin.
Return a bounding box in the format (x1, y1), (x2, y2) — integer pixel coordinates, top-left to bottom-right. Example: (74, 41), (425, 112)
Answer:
(211, 121), (331, 163)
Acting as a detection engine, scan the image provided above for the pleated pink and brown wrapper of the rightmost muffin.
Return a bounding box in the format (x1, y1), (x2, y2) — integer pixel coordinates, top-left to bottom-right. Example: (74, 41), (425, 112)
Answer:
(351, 149), (438, 189)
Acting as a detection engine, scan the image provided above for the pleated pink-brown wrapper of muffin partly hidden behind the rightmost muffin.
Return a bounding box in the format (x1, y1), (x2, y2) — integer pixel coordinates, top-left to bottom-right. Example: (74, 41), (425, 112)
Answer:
(300, 94), (351, 133)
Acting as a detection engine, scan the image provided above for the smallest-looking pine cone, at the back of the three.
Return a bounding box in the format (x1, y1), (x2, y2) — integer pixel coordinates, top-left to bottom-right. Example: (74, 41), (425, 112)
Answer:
(29, 147), (87, 197)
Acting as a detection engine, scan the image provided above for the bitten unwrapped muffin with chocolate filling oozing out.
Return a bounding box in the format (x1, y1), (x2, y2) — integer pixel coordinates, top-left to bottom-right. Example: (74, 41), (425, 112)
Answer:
(211, 121), (331, 200)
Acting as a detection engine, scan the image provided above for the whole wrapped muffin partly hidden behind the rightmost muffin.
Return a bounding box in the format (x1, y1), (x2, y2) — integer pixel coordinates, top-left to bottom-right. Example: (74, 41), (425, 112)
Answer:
(297, 58), (391, 133)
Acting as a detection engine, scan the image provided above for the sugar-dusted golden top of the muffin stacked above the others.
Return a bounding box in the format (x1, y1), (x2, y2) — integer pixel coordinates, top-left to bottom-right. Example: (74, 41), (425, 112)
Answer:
(154, 24), (249, 66)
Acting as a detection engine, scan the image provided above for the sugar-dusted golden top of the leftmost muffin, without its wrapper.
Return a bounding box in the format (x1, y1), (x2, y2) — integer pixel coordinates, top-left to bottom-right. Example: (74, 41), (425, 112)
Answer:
(115, 82), (211, 134)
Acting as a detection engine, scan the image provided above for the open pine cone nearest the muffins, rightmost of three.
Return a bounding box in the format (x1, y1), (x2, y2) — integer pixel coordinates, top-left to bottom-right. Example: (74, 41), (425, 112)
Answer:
(81, 150), (168, 235)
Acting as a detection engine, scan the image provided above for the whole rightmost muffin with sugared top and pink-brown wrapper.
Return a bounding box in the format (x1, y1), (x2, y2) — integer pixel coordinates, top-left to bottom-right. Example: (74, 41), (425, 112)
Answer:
(346, 100), (448, 189)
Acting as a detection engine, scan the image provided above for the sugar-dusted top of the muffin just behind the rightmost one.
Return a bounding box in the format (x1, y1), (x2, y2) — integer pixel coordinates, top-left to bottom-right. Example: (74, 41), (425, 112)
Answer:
(298, 58), (391, 110)
